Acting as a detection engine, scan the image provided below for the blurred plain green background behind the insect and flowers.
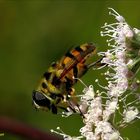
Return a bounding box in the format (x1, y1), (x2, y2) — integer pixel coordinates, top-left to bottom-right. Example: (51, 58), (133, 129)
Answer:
(0, 0), (140, 140)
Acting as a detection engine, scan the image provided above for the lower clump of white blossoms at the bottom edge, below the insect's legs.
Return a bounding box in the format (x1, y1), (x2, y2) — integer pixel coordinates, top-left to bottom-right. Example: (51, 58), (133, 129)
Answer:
(80, 86), (122, 140)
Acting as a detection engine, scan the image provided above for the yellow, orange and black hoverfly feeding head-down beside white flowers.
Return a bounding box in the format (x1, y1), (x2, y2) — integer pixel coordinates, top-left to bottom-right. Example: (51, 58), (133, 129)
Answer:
(32, 43), (100, 114)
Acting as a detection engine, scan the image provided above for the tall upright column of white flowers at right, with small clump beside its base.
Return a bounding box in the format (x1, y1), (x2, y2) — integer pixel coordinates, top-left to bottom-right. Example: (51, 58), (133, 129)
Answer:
(100, 8), (139, 126)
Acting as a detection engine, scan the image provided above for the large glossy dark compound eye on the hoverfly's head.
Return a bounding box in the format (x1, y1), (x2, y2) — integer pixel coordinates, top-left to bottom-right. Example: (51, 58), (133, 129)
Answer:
(32, 91), (51, 109)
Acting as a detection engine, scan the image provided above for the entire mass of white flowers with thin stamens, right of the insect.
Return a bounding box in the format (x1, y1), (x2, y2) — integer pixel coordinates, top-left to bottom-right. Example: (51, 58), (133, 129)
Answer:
(50, 8), (140, 140)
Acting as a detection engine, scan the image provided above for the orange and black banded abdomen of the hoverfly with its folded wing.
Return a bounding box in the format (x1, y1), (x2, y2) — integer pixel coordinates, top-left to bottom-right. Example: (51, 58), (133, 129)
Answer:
(60, 43), (96, 79)
